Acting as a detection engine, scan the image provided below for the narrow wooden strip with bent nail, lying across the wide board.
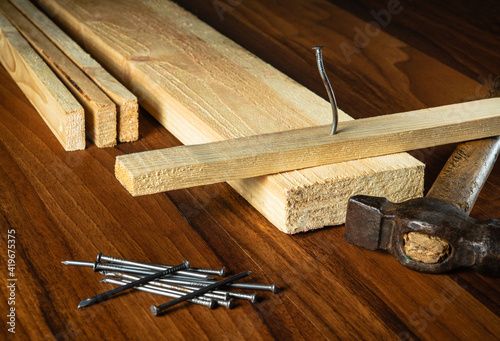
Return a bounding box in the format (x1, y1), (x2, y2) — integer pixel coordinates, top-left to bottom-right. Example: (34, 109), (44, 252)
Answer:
(115, 98), (500, 194)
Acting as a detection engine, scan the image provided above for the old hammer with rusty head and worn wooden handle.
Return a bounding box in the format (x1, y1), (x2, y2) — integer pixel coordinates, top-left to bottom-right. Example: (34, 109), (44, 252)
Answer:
(345, 82), (500, 277)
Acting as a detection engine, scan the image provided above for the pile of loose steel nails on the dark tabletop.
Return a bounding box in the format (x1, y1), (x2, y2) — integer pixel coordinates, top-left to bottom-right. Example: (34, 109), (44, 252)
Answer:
(62, 253), (278, 315)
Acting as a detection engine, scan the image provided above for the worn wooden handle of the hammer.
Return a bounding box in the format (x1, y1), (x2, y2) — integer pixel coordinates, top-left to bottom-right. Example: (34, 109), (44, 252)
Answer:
(427, 136), (500, 214)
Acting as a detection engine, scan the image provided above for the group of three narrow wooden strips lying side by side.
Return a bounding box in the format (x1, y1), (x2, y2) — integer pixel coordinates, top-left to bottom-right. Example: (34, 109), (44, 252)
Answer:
(0, 1), (138, 150)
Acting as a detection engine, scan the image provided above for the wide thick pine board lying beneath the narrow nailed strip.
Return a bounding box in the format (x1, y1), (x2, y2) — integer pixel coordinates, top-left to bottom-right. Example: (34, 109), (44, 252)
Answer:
(40, 0), (424, 233)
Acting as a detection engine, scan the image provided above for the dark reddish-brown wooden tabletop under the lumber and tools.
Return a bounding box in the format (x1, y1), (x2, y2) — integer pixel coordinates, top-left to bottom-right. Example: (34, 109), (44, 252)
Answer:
(0, 0), (500, 340)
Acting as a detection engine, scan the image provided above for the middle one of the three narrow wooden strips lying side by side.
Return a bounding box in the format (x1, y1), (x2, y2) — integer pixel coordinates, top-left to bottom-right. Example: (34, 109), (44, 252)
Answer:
(0, 2), (116, 148)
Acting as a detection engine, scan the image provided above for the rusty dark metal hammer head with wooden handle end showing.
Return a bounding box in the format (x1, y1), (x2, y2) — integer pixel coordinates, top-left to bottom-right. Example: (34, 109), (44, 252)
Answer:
(345, 195), (500, 276)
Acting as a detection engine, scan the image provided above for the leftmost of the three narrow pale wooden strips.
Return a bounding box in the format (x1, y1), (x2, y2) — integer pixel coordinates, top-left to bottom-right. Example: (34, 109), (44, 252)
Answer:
(0, 13), (85, 151)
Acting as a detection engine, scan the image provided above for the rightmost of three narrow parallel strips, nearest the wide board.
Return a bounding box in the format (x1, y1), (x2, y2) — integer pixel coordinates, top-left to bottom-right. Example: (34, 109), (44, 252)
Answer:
(11, 0), (139, 142)
